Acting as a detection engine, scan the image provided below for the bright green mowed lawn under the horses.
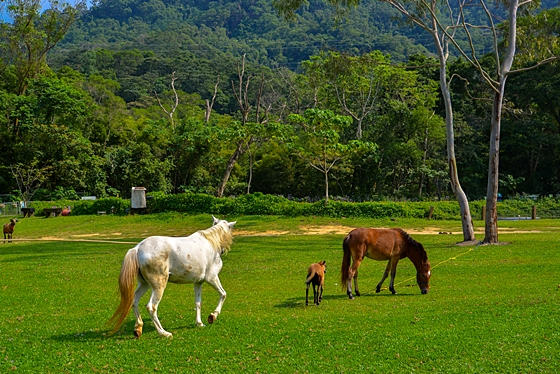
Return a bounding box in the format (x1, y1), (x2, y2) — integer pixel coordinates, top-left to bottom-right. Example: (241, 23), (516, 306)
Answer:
(0, 214), (560, 373)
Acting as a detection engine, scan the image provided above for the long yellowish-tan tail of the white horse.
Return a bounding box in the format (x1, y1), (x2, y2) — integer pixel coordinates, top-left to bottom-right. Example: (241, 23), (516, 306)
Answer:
(107, 247), (140, 335)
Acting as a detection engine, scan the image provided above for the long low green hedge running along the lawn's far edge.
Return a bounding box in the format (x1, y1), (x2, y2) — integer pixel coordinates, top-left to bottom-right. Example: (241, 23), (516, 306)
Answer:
(26, 192), (560, 220)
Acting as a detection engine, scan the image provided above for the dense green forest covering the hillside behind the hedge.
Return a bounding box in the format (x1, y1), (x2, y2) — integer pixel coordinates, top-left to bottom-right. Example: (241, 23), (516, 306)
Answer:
(0, 0), (560, 205)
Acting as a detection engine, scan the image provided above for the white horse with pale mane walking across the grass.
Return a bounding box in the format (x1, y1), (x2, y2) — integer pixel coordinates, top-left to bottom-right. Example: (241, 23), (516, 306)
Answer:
(108, 216), (237, 338)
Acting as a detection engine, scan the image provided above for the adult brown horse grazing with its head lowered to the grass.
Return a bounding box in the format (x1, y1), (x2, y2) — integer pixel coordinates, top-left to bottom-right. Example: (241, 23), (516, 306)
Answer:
(340, 228), (431, 299)
